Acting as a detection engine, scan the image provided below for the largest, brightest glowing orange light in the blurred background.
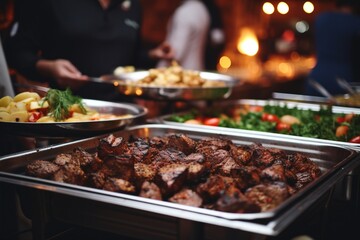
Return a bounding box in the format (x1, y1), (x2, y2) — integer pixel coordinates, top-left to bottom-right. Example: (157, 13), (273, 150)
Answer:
(237, 28), (259, 56)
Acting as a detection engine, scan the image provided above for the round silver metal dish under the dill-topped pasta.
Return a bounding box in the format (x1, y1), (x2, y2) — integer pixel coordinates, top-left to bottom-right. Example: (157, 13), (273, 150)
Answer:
(0, 99), (148, 138)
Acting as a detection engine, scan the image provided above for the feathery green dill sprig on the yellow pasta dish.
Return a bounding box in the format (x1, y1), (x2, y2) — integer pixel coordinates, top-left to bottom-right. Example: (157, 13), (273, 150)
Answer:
(44, 88), (86, 121)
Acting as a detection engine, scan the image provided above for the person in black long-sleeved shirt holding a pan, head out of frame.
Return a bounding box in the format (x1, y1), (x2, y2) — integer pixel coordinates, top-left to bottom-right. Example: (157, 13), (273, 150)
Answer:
(6, 0), (172, 100)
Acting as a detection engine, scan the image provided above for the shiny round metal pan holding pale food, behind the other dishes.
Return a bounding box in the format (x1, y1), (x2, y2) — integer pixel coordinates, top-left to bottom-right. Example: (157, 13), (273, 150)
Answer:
(100, 71), (240, 100)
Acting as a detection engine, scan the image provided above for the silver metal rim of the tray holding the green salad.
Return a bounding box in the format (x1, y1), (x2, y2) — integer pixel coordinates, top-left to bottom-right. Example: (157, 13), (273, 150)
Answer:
(154, 99), (360, 150)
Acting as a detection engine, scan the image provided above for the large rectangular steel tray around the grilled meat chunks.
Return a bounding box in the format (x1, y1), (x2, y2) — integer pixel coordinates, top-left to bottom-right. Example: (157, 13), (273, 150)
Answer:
(0, 124), (360, 235)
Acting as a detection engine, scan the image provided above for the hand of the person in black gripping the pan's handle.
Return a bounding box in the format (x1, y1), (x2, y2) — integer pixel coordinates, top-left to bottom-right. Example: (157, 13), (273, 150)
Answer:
(36, 59), (89, 89)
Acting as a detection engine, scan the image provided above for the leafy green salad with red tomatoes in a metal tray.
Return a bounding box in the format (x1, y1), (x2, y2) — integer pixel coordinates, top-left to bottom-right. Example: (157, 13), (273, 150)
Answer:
(166, 105), (360, 143)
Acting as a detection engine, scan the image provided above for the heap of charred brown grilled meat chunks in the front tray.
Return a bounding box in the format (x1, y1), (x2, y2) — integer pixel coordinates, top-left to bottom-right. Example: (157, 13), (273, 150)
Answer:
(25, 134), (321, 213)
